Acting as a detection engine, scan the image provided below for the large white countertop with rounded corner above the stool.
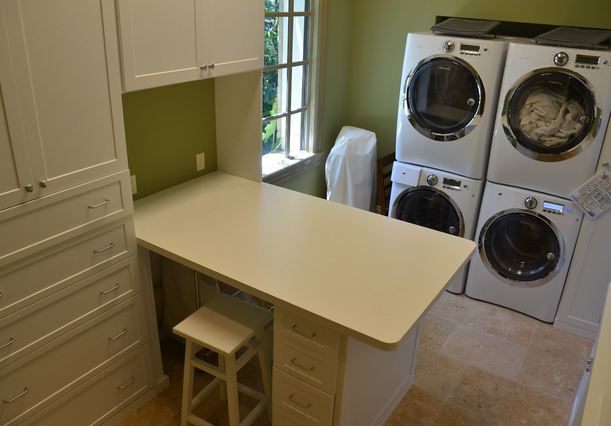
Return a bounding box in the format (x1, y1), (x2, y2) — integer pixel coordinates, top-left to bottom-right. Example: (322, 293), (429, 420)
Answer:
(135, 172), (475, 349)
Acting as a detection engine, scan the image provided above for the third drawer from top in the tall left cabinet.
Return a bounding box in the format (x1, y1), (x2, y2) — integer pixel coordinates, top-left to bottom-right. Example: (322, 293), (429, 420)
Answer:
(0, 257), (139, 368)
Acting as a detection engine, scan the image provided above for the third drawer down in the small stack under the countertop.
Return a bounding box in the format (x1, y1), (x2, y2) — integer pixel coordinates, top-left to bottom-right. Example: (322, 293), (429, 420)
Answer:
(272, 368), (333, 426)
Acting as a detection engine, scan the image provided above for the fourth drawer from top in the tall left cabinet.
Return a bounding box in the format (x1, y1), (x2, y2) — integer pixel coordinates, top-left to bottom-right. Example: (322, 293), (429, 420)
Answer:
(0, 296), (145, 424)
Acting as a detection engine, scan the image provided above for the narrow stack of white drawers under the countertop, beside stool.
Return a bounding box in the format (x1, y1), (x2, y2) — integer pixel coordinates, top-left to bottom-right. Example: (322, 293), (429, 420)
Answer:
(273, 307), (340, 426)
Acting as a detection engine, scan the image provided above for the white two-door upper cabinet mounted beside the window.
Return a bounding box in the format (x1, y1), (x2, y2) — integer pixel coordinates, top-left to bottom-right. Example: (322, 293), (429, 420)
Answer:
(117, 0), (264, 91)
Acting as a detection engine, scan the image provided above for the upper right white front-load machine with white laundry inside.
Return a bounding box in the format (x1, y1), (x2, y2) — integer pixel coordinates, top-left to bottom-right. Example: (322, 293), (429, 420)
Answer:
(488, 43), (611, 197)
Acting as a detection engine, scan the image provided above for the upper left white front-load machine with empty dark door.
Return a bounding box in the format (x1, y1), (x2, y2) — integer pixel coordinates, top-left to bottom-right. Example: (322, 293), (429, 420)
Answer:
(396, 34), (507, 179)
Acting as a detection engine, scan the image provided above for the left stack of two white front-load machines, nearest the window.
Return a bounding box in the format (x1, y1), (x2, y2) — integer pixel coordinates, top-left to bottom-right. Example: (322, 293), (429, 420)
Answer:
(389, 19), (507, 293)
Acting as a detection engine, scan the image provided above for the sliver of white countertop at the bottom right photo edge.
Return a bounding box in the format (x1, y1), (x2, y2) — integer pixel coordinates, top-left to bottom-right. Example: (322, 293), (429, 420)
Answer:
(581, 285), (611, 426)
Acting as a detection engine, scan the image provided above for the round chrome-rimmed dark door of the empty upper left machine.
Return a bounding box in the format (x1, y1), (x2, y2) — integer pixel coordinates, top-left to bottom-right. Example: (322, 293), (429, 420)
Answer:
(404, 55), (484, 141)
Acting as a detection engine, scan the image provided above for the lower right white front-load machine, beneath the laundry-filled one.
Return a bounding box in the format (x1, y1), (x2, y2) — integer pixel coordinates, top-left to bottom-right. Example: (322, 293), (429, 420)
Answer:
(465, 182), (583, 322)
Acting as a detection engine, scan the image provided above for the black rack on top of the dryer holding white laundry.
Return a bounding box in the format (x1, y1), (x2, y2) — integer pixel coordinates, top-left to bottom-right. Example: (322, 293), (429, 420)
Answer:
(535, 27), (611, 50)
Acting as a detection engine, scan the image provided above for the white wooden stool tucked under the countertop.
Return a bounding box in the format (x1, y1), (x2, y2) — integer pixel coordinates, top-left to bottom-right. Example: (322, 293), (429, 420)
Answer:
(173, 295), (272, 426)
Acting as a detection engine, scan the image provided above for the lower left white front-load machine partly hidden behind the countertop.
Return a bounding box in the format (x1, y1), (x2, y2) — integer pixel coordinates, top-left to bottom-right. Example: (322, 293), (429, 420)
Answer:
(388, 161), (483, 293)
